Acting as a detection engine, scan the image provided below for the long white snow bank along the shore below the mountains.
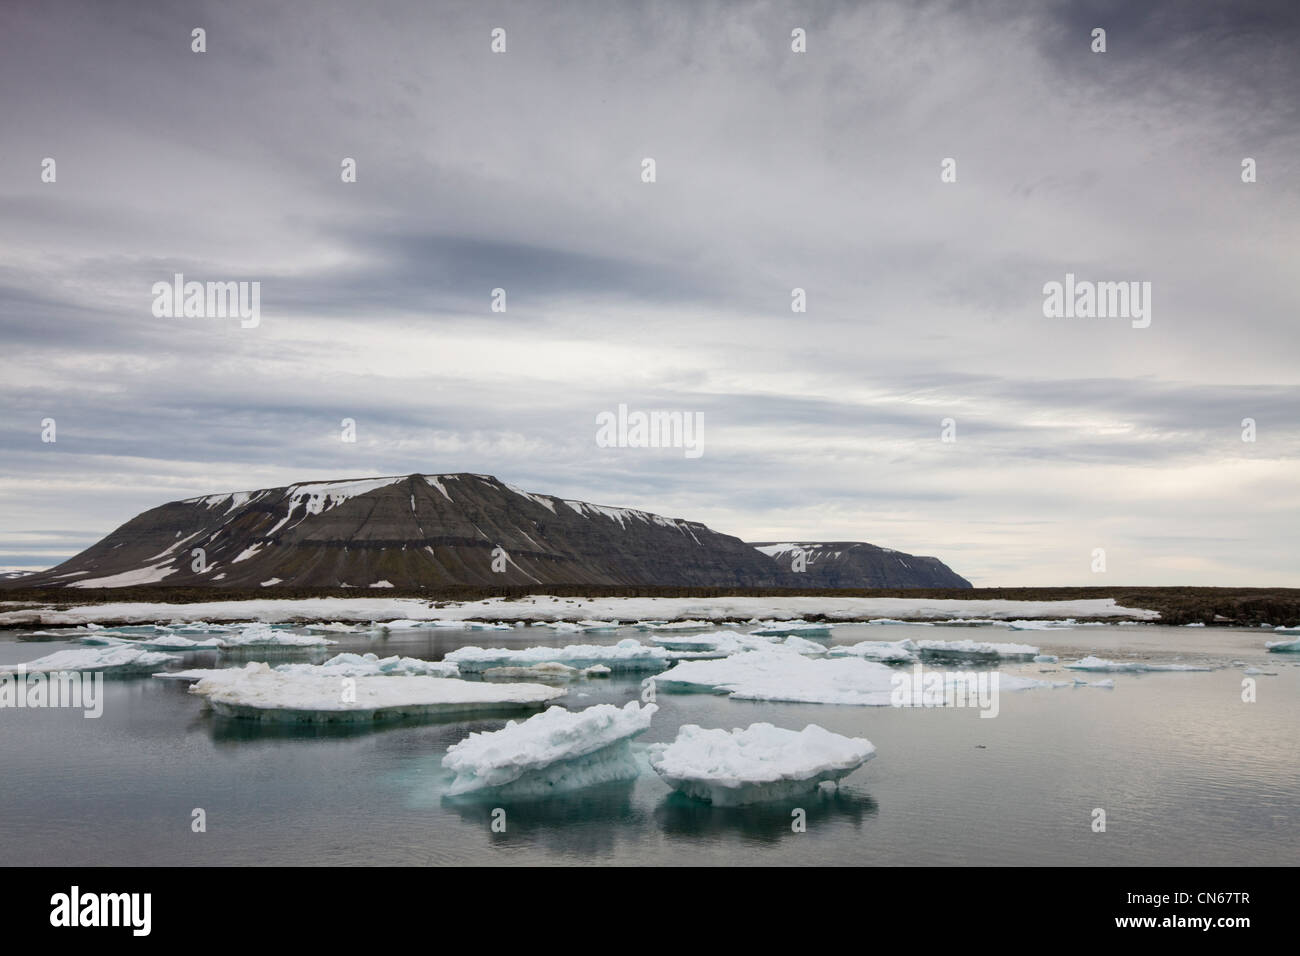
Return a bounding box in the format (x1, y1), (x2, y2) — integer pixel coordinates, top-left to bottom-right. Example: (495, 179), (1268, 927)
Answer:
(0, 594), (1160, 627)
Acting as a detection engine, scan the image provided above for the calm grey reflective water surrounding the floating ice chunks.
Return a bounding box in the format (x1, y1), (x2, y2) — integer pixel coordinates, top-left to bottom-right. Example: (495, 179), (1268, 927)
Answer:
(0, 626), (1300, 866)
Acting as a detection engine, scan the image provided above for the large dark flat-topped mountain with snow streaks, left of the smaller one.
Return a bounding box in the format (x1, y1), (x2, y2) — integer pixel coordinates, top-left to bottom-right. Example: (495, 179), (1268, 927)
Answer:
(7, 473), (970, 589)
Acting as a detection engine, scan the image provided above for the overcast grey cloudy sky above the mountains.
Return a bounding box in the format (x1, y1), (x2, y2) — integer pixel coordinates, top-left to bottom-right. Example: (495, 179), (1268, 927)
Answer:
(0, 0), (1300, 587)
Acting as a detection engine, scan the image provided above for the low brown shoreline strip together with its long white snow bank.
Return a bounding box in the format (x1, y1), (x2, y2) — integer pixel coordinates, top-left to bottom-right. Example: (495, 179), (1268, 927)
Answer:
(0, 585), (1300, 630)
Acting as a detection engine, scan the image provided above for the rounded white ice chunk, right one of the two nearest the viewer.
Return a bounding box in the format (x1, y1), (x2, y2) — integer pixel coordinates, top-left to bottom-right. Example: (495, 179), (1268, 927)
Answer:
(649, 723), (876, 806)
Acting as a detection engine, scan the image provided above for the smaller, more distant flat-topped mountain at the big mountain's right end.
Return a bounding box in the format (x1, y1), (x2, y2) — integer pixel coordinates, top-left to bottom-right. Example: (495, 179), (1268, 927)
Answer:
(750, 541), (971, 588)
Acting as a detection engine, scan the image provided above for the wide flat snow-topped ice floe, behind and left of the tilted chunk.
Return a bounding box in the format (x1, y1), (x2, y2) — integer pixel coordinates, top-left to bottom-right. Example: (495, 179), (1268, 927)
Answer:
(190, 663), (564, 723)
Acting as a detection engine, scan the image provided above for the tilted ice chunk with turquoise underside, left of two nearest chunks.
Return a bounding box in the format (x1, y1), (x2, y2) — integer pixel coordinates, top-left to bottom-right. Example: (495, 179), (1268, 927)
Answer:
(442, 701), (658, 796)
